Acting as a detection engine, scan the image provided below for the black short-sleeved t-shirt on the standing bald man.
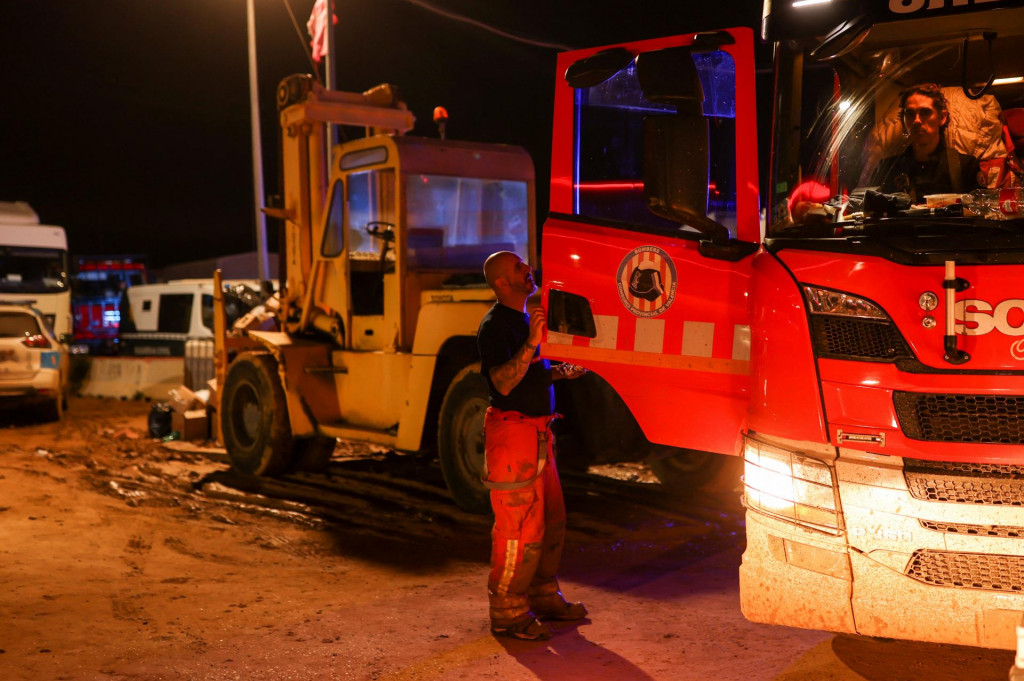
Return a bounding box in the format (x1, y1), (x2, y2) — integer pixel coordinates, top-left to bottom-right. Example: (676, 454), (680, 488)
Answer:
(476, 303), (555, 416)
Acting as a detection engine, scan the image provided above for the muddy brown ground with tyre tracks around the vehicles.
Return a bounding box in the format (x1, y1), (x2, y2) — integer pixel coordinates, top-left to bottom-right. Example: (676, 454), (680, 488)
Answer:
(0, 398), (1013, 681)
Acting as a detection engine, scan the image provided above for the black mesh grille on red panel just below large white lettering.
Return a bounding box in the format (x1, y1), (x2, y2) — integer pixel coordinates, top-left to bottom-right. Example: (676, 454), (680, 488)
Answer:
(893, 391), (1024, 444)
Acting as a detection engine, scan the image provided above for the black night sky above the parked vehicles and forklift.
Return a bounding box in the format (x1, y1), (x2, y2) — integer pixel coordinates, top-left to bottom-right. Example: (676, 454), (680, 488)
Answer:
(0, 0), (765, 266)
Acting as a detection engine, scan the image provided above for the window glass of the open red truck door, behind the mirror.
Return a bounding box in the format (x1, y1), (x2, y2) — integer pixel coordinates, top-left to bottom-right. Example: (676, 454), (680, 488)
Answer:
(573, 52), (737, 236)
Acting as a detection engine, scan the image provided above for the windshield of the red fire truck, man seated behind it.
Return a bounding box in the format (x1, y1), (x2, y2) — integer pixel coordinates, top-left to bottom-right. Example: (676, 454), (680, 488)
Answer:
(768, 9), (1024, 243)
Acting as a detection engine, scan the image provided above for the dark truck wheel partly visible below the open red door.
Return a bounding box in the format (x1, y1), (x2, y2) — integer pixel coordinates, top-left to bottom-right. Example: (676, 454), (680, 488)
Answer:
(647, 444), (743, 492)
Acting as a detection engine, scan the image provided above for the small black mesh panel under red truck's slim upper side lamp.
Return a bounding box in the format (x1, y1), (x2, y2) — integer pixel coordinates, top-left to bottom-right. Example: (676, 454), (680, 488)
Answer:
(811, 315), (911, 361)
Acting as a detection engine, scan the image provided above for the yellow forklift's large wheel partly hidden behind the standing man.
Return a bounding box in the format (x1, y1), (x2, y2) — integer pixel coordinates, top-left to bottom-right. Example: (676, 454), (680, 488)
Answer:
(437, 364), (490, 513)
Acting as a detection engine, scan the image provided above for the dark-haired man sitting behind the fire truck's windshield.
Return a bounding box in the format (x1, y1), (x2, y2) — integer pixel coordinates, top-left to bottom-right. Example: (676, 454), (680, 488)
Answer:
(870, 83), (979, 204)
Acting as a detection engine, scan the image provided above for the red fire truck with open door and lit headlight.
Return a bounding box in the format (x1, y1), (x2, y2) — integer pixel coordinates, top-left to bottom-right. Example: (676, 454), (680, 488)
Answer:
(543, 0), (1024, 648)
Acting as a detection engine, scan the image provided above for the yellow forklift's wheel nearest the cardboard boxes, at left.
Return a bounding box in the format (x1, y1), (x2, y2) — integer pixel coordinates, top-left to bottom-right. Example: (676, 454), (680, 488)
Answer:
(220, 352), (294, 475)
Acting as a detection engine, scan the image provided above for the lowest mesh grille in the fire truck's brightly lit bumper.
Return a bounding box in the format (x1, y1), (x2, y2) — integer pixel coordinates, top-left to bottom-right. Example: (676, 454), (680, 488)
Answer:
(906, 549), (1024, 592)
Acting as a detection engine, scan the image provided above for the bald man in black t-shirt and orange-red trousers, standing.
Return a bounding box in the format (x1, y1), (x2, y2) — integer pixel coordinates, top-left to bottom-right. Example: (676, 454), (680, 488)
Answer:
(477, 251), (587, 641)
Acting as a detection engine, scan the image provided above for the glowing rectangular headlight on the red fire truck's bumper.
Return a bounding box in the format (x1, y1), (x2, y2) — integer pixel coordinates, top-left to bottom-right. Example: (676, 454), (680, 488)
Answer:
(743, 437), (842, 535)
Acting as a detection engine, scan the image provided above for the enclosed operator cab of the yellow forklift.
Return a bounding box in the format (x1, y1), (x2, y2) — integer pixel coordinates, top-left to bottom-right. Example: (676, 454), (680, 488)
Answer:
(314, 135), (536, 352)
